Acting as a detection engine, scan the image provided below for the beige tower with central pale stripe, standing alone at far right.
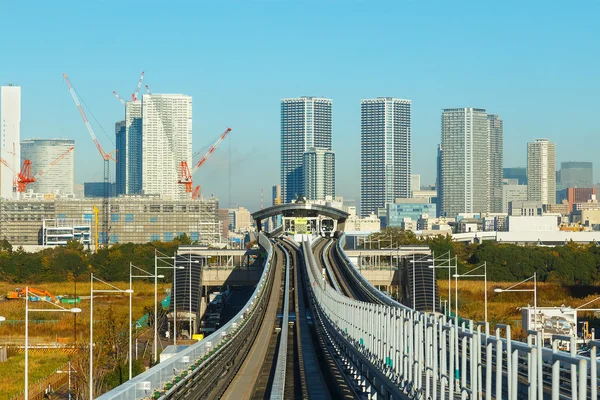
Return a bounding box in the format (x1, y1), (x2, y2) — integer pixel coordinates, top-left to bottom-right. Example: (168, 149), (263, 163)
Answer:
(527, 139), (556, 204)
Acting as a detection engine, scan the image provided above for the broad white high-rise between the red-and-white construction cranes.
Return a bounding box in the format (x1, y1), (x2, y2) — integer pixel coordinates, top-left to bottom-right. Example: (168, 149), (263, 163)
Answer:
(142, 94), (192, 200)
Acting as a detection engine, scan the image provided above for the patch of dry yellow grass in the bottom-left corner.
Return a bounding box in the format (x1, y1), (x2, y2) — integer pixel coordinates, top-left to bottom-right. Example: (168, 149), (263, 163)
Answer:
(0, 353), (68, 400)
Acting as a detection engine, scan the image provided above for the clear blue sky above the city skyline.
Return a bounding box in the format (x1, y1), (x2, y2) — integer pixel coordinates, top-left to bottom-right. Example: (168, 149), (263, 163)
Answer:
(0, 0), (600, 209)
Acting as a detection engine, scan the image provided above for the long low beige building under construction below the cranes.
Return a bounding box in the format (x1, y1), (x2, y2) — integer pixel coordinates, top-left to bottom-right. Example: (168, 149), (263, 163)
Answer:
(0, 196), (222, 246)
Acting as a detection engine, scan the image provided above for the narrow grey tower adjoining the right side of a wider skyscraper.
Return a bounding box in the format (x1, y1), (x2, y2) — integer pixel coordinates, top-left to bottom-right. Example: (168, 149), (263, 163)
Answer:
(487, 114), (504, 213)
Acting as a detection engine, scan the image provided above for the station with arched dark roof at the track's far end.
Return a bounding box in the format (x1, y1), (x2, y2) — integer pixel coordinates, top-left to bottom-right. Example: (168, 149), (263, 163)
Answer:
(252, 199), (350, 236)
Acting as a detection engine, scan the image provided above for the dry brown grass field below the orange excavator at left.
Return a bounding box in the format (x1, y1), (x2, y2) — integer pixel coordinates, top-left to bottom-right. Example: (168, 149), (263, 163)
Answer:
(0, 281), (170, 344)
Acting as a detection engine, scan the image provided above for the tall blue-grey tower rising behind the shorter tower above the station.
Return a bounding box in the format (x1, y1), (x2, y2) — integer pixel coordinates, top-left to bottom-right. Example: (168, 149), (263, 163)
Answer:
(281, 97), (332, 203)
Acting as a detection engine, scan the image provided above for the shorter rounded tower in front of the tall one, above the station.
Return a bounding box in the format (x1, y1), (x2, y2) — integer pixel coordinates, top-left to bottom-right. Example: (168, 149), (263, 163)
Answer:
(302, 147), (335, 200)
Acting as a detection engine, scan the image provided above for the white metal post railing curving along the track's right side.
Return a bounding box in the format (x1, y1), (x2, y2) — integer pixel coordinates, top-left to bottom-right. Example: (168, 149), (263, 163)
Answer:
(303, 236), (600, 400)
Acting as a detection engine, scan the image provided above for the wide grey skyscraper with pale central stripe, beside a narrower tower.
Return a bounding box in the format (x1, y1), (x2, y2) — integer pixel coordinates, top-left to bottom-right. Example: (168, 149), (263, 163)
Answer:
(438, 108), (489, 217)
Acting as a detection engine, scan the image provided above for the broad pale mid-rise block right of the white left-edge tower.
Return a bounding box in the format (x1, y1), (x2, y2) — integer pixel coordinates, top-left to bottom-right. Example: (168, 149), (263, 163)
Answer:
(21, 139), (75, 194)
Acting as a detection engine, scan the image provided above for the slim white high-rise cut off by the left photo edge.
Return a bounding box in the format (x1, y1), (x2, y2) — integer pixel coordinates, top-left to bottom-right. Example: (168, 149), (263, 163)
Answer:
(0, 85), (21, 199)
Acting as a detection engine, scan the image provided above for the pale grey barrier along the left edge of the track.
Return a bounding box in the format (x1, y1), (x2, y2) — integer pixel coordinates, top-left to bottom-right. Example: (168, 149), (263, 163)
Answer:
(98, 233), (273, 400)
